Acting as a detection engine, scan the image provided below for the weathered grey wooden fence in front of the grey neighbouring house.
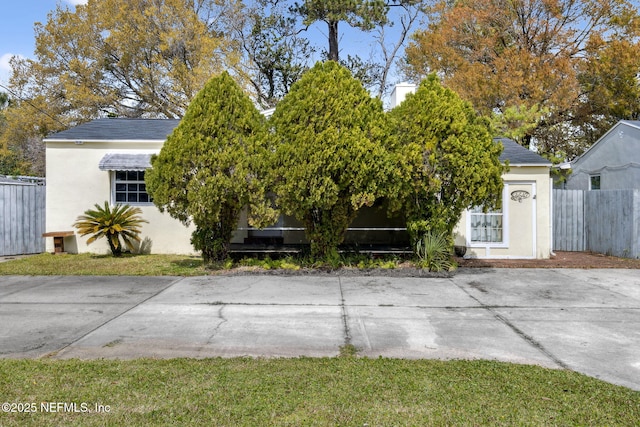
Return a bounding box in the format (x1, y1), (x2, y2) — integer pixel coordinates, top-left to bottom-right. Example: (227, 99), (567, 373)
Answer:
(553, 190), (640, 258)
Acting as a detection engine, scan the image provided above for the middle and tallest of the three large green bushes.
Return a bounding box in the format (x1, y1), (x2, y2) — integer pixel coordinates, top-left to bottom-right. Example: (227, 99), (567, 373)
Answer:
(270, 61), (396, 259)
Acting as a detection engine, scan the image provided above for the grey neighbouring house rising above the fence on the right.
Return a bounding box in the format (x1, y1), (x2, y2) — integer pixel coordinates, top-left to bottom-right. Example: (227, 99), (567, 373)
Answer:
(564, 120), (640, 190)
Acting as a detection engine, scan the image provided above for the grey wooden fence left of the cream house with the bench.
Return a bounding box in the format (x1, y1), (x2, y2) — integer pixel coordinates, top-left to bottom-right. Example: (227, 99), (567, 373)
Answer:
(0, 177), (46, 256)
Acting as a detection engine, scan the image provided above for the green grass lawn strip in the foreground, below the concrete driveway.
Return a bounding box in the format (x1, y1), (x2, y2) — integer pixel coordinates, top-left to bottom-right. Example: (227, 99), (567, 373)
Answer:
(0, 357), (640, 426)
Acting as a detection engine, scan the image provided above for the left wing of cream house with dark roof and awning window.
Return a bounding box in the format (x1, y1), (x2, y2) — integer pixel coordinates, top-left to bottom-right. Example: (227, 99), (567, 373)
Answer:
(44, 118), (200, 254)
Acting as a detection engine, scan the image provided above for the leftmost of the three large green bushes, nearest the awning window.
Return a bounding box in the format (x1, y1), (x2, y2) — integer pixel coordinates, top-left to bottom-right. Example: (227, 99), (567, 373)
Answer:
(145, 72), (276, 263)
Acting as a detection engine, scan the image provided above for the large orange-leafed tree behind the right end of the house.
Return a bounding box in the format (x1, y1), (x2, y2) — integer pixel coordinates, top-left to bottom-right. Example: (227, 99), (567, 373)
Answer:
(406, 0), (640, 161)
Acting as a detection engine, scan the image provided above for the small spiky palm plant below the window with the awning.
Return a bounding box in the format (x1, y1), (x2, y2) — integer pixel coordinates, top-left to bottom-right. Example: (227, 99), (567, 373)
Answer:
(73, 202), (149, 256)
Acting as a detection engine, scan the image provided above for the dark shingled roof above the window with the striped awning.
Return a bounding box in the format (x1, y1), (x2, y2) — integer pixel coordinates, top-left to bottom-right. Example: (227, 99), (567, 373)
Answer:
(45, 119), (180, 141)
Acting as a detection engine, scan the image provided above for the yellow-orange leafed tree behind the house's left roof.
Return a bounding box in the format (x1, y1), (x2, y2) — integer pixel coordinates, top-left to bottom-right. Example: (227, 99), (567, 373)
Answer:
(0, 0), (240, 176)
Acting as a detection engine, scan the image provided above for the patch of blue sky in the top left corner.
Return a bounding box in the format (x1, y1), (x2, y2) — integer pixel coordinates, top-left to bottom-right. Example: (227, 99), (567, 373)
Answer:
(0, 0), (87, 84)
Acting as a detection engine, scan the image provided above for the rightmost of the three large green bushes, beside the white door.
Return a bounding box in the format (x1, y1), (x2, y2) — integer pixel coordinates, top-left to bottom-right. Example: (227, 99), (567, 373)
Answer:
(389, 75), (503, 245)
